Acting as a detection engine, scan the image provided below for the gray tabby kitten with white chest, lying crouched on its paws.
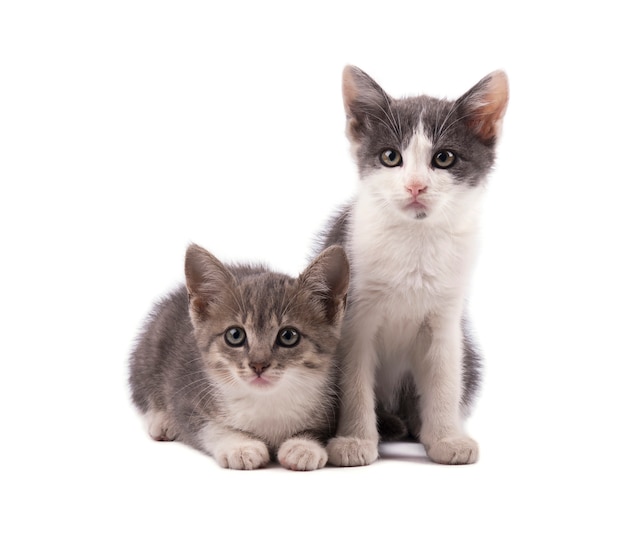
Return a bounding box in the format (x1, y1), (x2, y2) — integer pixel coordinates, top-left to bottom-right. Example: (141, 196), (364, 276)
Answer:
(130, 245), (349, 470)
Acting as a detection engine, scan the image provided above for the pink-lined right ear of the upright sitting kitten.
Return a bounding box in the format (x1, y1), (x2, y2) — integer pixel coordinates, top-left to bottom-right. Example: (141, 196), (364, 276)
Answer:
(458, 70), (509, 142)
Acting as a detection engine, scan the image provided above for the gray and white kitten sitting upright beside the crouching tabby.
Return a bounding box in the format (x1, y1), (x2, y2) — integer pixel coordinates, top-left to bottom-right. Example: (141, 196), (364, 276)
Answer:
(316, 66), (508, 466)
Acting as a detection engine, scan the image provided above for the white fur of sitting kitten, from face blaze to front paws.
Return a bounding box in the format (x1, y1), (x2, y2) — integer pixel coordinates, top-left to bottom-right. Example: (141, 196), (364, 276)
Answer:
(328, 130), (482, 465)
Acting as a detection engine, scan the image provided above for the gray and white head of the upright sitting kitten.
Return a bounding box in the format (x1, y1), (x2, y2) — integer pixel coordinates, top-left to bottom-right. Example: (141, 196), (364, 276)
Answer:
(343, 66), (508, 224)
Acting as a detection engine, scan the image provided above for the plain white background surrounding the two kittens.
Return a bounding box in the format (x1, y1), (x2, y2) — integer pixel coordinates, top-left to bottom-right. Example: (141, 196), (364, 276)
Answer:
(0, 0), (626, 533)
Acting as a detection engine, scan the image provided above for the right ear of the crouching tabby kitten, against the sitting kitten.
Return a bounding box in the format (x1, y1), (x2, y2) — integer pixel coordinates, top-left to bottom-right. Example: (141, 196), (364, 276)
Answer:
(298, 245), (350, 324)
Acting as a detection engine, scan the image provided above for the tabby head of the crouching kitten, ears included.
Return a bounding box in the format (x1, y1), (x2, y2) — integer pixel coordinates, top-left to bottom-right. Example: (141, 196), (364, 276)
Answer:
(185, 245), (349, 393)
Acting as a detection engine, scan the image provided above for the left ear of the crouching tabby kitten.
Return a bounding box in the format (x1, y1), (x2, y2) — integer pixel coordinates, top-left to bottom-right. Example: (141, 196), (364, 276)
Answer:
(185, 244), (234, 320)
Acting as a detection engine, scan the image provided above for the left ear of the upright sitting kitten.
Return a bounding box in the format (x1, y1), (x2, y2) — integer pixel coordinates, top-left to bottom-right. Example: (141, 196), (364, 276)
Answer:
(342, 65), (391, 142)
